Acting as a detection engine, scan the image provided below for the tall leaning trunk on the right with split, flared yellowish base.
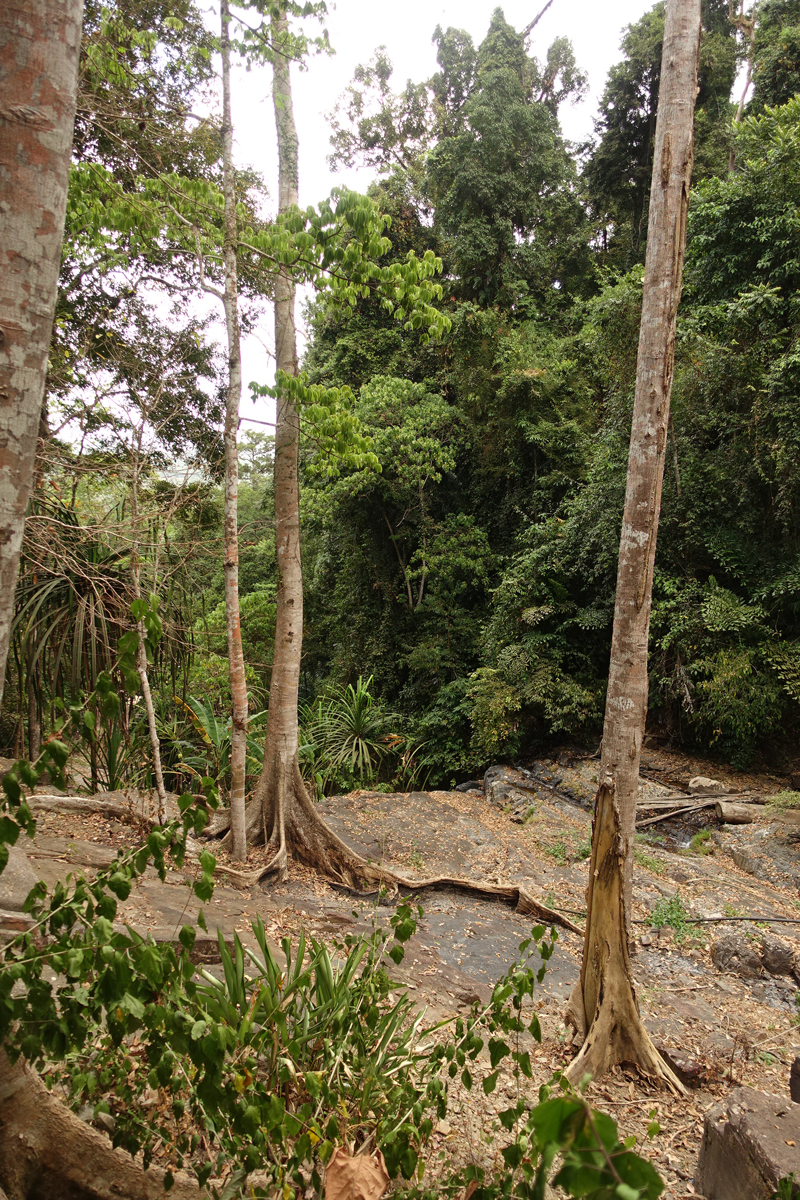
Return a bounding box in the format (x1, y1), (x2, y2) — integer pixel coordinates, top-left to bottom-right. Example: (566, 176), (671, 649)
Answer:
(567, 0), (700, 1090)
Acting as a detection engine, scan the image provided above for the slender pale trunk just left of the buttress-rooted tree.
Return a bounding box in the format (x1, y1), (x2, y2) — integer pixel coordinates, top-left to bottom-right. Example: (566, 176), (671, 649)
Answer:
(221, 0), (247, 862)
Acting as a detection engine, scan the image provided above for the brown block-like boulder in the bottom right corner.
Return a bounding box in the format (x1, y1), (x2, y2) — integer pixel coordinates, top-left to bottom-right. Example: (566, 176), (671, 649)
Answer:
(694, 1087), (800, 1200)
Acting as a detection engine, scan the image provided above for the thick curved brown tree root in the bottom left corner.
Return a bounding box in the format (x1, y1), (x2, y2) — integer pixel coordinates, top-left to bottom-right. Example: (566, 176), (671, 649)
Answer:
(0, 1049), (207, 1200)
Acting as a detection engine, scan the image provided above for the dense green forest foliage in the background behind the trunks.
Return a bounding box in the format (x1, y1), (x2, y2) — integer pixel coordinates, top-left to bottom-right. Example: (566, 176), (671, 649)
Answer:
(6, 0), (800, 791)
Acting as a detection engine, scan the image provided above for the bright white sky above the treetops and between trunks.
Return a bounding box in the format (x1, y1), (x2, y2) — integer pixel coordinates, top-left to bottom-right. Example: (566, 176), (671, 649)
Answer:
(226, 0), (652, 428)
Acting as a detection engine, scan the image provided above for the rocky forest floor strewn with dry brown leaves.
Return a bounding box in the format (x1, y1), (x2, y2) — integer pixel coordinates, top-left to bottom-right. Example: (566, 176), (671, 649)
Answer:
(17, 750), (800, 1200)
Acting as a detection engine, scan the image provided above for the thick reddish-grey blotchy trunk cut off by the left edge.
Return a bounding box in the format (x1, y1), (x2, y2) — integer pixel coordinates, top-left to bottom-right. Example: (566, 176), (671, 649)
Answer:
(0, 0), (83, 701)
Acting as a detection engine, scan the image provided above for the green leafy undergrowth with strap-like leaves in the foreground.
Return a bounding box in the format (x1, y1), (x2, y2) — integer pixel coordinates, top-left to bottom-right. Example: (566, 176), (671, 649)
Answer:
(0, 646), (663, 1200)
